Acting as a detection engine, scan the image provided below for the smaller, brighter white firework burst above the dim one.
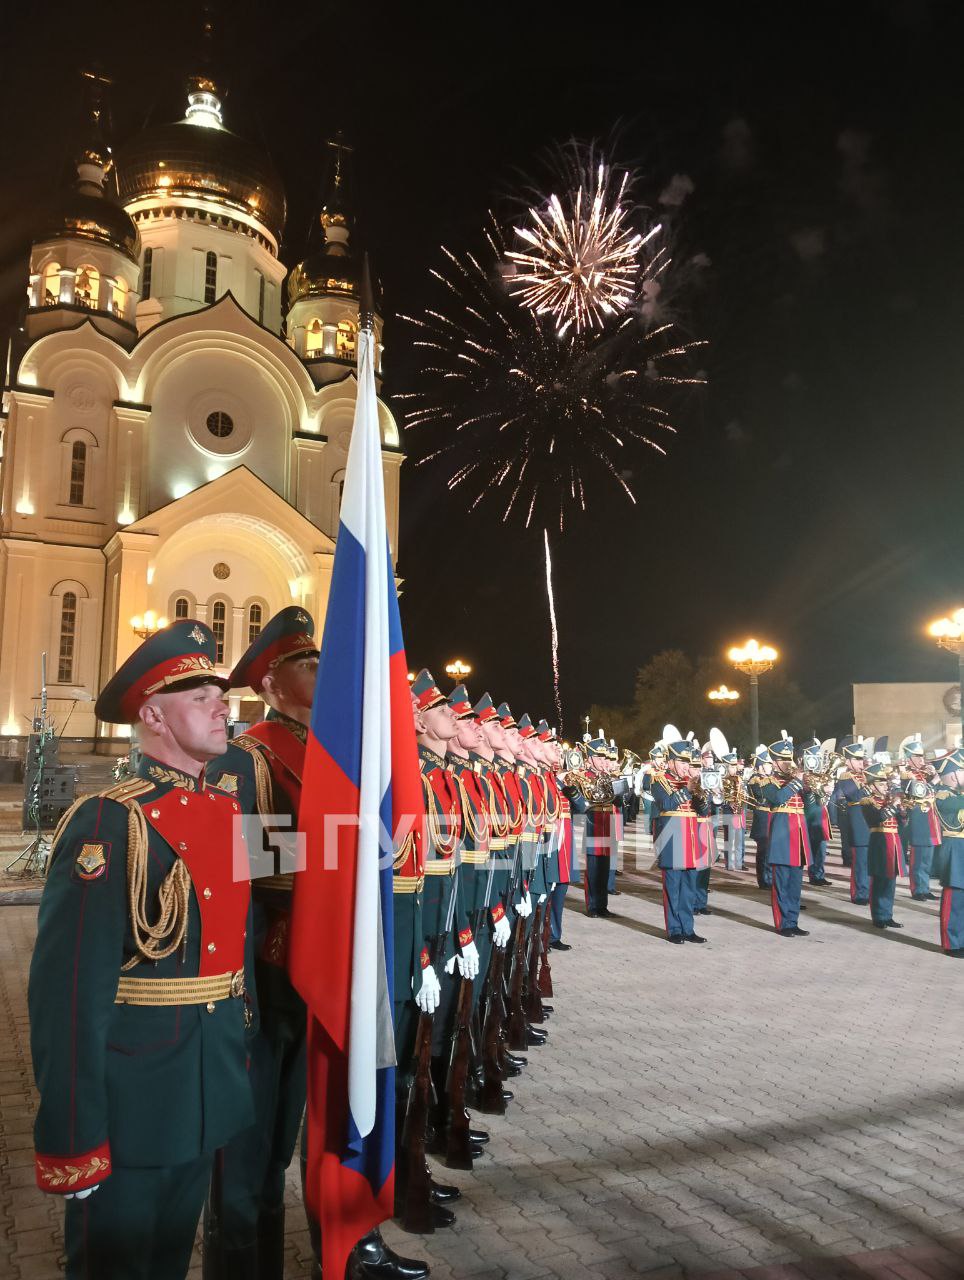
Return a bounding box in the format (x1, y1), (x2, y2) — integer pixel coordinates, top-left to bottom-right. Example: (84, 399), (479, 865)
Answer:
(506, 161), (662, 338)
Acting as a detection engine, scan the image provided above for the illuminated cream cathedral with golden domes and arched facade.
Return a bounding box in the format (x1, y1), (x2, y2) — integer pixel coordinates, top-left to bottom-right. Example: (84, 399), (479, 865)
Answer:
(0, 77), (402, 739)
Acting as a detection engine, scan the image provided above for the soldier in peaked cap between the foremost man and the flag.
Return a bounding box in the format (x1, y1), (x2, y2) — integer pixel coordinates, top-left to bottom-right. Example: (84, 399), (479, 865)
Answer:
(204, 605), (428, 1280)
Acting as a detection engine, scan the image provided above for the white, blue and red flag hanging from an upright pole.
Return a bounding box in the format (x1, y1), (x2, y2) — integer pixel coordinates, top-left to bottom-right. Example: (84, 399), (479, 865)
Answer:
(289, 312), (422, 1280)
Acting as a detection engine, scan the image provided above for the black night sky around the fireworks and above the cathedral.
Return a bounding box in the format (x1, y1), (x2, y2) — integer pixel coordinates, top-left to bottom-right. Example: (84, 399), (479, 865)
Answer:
(0, 0), (964, 732)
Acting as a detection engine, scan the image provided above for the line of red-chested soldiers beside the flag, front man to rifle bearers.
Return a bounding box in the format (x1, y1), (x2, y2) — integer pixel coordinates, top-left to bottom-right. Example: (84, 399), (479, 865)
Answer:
(29, 607), (611, 1280)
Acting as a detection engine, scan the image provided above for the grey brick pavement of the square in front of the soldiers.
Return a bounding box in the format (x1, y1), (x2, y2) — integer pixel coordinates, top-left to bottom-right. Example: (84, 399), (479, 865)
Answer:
(0, 819), (964, 1280)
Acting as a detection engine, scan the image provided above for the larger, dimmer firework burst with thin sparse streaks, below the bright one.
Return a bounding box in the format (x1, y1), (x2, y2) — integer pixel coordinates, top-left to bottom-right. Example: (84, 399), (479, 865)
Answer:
(396, 221), (704, 529)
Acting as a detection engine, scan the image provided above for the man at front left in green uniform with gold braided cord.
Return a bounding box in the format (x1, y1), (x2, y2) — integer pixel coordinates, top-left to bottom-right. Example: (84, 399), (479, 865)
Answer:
(28, 620), (253, 1280)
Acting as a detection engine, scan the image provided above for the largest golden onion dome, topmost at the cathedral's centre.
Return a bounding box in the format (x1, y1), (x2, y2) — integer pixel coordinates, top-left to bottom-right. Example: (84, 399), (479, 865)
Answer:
(116, 83), (285, 241)
